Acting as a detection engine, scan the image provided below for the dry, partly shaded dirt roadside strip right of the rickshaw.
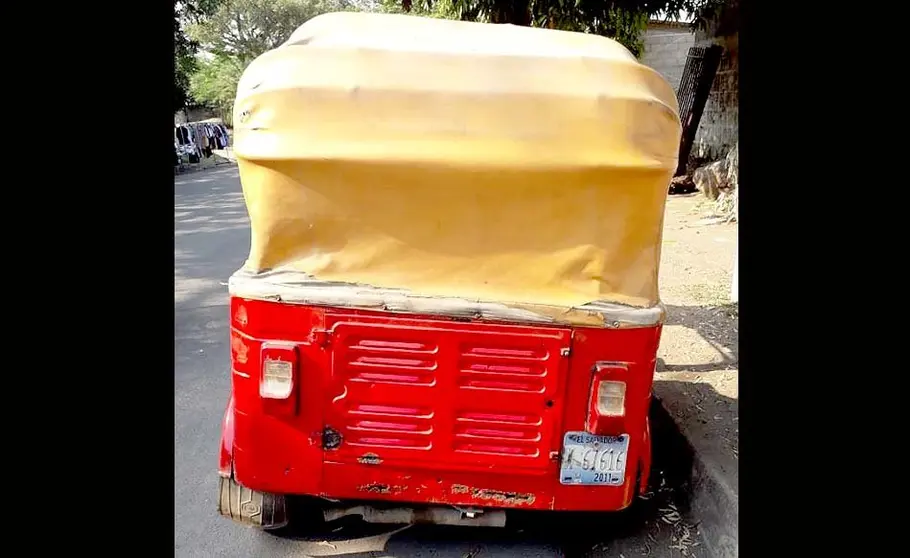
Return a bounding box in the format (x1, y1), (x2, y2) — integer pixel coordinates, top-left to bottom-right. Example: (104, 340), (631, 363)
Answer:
(654, 194), (739, 483)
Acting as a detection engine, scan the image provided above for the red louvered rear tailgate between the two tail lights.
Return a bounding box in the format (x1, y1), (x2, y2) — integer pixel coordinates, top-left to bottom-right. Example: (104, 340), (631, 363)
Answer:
(325, 312), (571, 474)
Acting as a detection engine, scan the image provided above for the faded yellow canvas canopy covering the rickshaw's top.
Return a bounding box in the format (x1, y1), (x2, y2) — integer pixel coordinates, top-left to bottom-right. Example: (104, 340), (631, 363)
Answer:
(231, 13), (680, 328)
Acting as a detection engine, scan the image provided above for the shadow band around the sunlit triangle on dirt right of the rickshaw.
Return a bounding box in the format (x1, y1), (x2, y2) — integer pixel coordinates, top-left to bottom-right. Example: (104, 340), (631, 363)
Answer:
(657, 304), (739, 372)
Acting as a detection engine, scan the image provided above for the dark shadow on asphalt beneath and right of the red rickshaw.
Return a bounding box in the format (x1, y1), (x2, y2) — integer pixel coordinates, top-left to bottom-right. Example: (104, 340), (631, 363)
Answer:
(263, 404), (694, 558)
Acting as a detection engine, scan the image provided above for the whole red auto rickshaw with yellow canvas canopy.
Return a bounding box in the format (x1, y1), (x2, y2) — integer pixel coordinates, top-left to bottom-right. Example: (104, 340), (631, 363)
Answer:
(219, 13), (681, 529)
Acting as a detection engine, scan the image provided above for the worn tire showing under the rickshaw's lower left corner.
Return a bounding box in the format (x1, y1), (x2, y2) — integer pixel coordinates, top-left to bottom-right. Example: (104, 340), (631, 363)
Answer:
(218, 477), (288, 531)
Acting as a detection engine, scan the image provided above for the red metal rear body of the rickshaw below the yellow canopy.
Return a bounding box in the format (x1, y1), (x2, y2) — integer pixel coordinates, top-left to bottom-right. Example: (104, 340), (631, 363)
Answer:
(220, 298), (660, 511)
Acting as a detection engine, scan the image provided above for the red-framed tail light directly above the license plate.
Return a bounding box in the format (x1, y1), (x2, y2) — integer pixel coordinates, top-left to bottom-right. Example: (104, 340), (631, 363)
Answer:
(586, 362), (629, 436)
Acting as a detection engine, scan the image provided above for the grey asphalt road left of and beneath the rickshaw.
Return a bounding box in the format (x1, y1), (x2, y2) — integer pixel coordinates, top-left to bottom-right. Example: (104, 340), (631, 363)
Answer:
(174, 165), (702, 558)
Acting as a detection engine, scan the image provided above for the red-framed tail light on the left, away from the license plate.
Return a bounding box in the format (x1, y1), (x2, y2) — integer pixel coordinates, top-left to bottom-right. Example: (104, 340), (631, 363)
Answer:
(259, 341), (300, 414)
